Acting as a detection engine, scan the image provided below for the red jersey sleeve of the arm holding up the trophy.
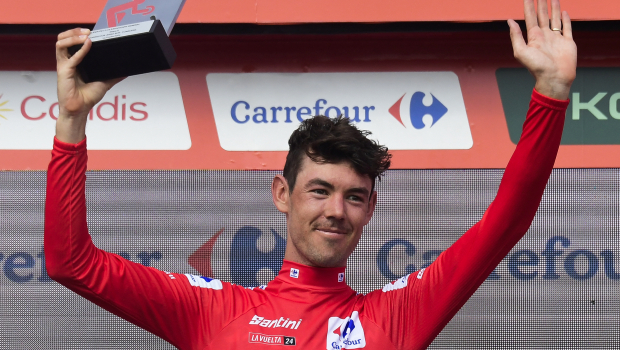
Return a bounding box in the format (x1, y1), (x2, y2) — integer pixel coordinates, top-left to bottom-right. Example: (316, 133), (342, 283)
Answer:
(44, 140), (237, 349)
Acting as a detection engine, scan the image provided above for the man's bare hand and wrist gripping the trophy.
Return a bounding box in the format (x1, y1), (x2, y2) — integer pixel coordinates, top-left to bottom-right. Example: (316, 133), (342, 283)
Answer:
(56, 28), (122, 143)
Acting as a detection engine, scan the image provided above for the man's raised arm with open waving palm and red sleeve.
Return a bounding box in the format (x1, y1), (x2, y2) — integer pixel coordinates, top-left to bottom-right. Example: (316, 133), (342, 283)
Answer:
(372, 0), (577, 349)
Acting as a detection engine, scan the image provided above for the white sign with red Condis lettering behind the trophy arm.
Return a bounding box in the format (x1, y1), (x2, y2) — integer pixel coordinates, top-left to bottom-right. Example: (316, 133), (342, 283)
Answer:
(0, 72), (191, 150)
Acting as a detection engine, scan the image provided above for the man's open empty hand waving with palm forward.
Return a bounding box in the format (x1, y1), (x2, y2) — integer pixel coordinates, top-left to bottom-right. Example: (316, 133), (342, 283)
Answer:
(508, 0), (577, 100)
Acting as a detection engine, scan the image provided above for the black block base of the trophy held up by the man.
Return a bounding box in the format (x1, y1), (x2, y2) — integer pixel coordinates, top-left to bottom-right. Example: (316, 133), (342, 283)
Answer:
(69, 20), (177, 83)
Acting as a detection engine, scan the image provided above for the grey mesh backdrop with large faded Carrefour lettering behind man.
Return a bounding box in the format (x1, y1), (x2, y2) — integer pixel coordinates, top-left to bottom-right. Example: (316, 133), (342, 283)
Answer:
(0, 169), (620, 349)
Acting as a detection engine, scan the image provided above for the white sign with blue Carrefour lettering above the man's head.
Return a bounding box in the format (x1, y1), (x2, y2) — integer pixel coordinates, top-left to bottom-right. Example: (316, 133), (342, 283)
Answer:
(207, 72), (473, 151)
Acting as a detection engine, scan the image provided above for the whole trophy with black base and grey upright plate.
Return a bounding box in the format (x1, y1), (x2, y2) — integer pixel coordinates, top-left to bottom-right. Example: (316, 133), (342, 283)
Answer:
(69, 0), (185, 83)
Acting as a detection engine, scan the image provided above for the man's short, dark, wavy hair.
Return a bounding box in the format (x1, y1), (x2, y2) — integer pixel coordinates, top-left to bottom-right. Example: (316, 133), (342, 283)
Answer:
(283, 115), (392, 192)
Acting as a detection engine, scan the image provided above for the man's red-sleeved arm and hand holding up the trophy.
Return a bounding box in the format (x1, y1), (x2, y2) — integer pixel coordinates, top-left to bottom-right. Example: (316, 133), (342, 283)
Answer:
(44, 29), (248, 349)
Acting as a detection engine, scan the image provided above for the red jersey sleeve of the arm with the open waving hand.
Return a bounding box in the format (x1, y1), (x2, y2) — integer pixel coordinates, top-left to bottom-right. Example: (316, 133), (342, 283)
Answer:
(368, 91), (568, 349)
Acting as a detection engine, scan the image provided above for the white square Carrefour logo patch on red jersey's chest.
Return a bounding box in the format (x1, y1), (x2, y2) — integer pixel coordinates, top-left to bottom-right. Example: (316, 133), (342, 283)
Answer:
(327, 311), (366, 350)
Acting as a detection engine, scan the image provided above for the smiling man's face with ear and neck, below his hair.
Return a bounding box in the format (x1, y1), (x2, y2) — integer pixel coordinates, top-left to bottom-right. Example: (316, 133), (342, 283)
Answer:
(272, 156), (377, 267)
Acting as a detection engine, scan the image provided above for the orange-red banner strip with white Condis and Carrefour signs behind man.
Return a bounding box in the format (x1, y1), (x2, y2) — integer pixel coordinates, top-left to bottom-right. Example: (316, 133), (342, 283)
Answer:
(0, 67), (620, 170)
